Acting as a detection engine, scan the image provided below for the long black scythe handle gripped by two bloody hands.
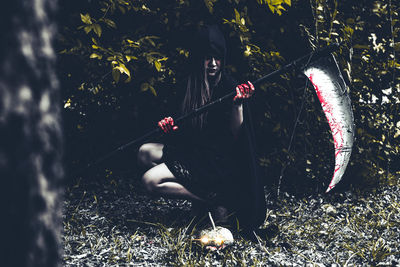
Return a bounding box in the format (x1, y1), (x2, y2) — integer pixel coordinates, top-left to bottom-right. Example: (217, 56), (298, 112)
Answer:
(87, 43), (339, 171)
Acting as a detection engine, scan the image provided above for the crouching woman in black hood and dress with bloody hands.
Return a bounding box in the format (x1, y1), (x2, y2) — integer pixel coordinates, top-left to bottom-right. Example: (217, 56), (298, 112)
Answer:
(138, 26), (265, 232)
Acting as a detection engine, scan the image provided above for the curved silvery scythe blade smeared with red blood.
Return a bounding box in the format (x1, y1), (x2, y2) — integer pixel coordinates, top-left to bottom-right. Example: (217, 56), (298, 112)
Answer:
(303, 54), (354, 192)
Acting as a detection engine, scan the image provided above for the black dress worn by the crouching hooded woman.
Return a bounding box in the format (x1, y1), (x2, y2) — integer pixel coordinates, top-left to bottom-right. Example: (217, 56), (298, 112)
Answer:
(162, 73), (265, 230)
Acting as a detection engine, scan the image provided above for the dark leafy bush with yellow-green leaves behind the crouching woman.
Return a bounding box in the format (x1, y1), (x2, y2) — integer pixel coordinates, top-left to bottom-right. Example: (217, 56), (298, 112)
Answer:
(58, 0), (400, 192)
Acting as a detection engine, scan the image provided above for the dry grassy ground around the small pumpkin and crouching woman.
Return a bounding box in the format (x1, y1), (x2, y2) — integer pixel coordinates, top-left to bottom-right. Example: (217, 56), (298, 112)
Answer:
(64, 174), (400, 266)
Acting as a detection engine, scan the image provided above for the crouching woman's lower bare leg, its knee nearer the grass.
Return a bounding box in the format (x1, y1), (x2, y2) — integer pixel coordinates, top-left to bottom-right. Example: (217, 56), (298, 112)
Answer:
(143, 163), (204, 201)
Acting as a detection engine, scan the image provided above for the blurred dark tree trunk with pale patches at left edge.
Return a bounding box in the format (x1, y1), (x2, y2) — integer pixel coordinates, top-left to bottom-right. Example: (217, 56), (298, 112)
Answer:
(0, 0), (63, 267)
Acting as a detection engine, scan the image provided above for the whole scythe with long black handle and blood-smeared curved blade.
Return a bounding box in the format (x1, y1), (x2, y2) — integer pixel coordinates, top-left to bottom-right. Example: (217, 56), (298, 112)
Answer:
(85, 43), (354, 192)
